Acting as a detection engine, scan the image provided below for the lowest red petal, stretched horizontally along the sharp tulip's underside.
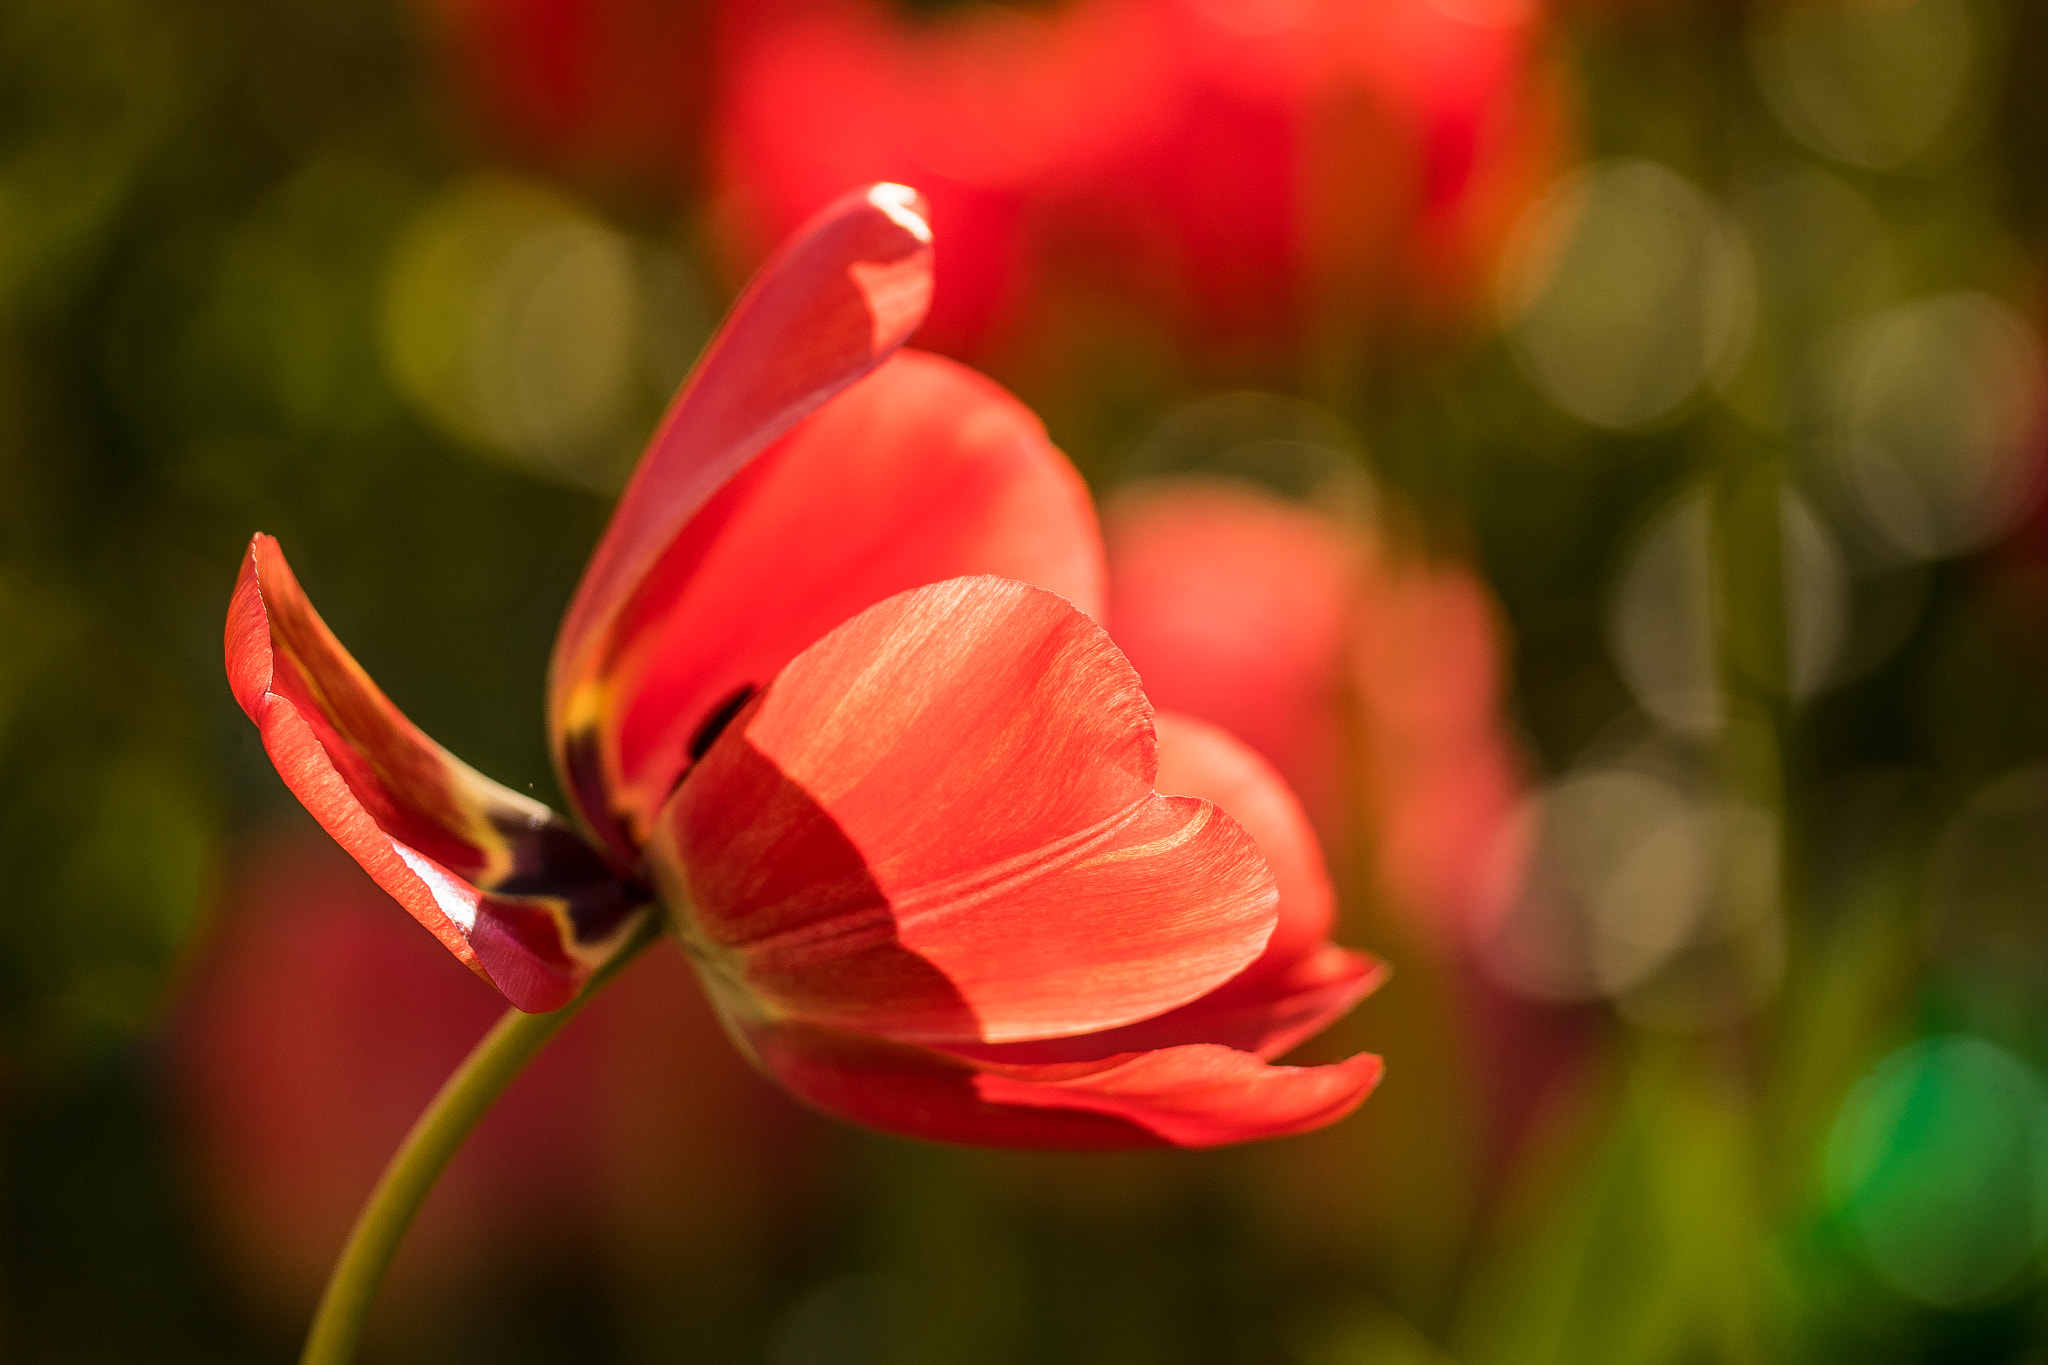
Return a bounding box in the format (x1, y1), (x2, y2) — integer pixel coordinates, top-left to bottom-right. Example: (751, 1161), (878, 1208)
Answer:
(745, 1025), (1382, 1150)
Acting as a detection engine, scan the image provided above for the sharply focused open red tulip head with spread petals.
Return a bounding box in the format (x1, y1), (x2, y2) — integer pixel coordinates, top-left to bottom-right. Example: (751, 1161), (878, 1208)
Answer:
(227, 186), (1380, 1146)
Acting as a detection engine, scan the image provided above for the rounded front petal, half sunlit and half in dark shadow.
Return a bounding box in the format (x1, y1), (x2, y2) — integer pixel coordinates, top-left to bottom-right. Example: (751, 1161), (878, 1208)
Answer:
(649, 577), (1276, 1044)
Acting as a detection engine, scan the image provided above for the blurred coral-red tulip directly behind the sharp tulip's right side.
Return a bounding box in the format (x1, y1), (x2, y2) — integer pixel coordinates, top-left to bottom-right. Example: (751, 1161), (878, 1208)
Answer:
(1110, 479), (1520, 941)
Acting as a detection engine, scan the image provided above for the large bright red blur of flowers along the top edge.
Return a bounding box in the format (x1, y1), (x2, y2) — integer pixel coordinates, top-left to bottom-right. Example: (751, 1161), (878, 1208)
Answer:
(713, 0), (1561, 354)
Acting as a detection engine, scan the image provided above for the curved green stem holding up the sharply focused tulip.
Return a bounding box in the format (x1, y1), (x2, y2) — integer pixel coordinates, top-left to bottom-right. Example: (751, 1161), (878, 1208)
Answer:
(299, 915), (659, 1365)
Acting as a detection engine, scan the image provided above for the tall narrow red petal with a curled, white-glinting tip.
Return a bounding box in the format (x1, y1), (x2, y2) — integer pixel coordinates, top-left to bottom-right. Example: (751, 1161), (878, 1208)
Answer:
(549, 184), (932, 851)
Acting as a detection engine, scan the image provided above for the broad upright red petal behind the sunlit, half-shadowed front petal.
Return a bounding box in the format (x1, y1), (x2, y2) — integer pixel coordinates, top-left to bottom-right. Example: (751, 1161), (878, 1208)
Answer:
(598, 352), (1106, 841)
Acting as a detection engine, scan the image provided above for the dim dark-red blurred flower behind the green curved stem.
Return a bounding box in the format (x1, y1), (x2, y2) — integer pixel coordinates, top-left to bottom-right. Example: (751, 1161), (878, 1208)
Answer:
(170, 835), (813, 1318)
